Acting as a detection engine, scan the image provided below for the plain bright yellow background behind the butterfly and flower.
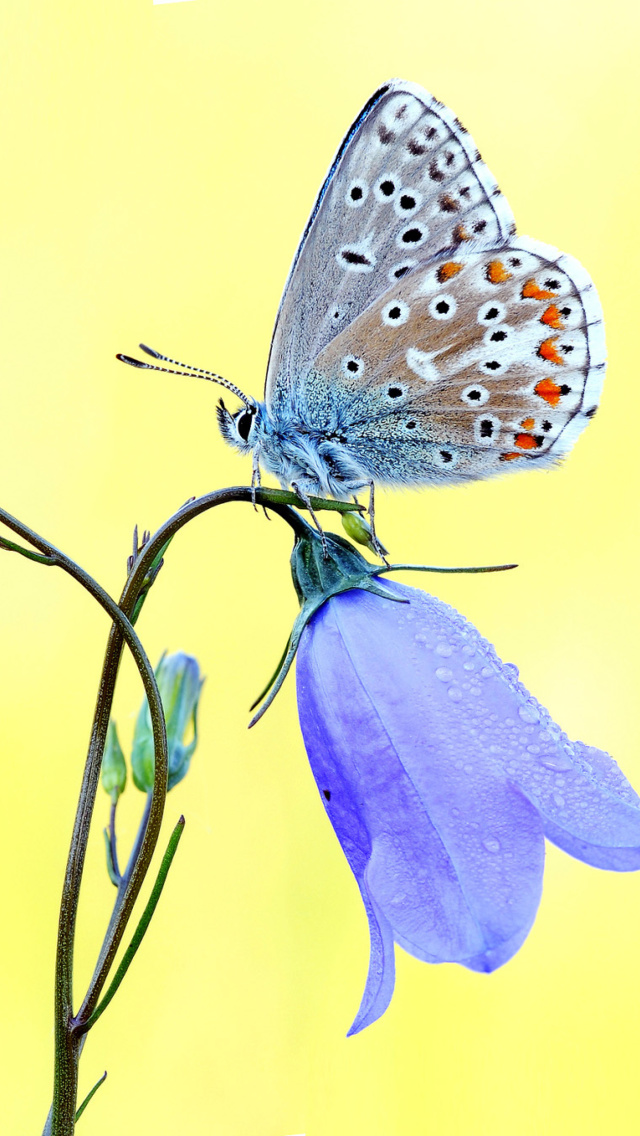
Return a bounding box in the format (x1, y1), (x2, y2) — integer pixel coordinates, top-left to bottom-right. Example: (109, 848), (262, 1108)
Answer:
(0, 0), (640, 1136)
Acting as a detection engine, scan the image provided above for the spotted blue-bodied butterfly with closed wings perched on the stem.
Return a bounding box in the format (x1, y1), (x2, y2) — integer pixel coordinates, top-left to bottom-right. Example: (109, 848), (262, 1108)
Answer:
(118, 80), (606, 540)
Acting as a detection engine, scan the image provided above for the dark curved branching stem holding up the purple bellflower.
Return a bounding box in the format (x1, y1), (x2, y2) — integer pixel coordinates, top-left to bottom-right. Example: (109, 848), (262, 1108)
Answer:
(0, 486), (345, 1136)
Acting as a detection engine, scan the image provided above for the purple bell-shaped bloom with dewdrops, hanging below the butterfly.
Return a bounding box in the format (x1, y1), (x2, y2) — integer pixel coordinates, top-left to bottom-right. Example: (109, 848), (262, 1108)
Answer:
(297, 582), (640, 1034)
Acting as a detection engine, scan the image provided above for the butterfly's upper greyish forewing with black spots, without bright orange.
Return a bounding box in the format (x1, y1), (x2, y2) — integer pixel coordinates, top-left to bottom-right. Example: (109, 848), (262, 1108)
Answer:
(265, 80), (515, 411)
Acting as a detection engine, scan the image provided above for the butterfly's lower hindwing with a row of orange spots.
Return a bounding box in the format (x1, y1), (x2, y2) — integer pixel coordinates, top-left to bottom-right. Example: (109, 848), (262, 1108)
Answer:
(311, 237), (606, 485)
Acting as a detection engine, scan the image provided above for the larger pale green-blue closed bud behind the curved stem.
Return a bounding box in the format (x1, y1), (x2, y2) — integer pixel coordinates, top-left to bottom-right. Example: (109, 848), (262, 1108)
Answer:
(131, 651), (203, 793)
